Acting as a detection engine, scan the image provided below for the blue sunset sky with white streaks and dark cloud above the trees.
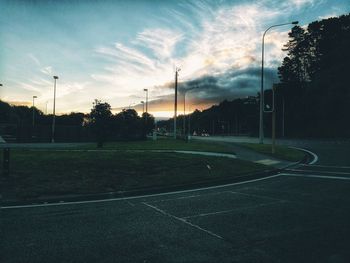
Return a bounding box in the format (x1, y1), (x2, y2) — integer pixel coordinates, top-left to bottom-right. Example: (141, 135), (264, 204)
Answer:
(0, 0), (350, 117)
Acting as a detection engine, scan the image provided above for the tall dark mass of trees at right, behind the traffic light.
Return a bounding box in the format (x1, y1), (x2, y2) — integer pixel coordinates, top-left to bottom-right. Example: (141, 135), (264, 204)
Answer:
(278, 14), (350, 137)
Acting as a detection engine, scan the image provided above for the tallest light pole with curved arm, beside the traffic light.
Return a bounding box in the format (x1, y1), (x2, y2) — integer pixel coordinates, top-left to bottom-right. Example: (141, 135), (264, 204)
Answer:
(259, 21), (299, 144)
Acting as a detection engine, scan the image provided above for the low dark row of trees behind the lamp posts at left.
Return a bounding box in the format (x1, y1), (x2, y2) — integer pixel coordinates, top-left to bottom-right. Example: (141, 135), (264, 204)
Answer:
(0, 100), (154, 146)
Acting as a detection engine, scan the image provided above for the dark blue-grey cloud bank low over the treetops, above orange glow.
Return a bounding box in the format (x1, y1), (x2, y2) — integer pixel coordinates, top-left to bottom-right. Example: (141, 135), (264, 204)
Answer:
(130, 67), (278, 110)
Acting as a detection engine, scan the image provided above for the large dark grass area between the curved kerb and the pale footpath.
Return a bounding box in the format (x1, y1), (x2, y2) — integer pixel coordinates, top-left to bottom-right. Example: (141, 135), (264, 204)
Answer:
(3, 150), (267, 199)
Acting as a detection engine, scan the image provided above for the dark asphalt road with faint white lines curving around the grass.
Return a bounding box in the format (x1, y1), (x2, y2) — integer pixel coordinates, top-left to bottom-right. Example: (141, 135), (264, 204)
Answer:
(0, 141), (350, 263)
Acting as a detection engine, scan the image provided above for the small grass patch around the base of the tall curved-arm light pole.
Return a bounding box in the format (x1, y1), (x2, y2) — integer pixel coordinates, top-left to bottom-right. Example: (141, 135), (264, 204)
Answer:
(241, 143), (305, 162)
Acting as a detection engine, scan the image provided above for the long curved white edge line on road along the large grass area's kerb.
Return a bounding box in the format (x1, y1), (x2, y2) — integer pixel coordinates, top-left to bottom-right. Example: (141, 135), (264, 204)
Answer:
(1, 174), (281, 209)
